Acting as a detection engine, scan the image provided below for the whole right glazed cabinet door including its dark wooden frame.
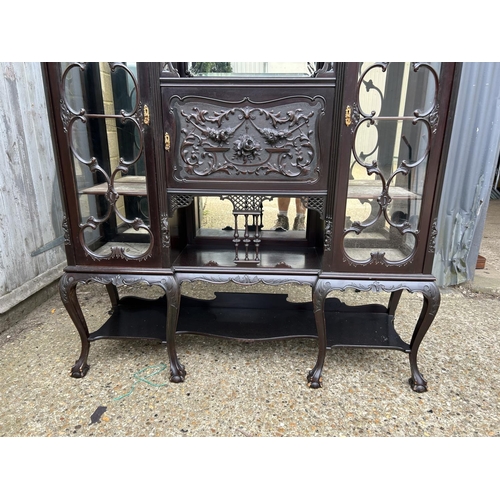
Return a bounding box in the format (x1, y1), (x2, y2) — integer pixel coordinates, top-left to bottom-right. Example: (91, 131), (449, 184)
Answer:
(326, 63), (454, 274)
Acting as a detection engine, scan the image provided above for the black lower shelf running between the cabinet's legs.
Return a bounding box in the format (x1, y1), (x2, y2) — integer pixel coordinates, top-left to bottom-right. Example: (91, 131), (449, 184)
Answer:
(89, 293), (410, 352)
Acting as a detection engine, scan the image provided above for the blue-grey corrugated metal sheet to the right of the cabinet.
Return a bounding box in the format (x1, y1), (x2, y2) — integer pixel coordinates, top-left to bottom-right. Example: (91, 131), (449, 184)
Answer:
(433, 63), (500, 286)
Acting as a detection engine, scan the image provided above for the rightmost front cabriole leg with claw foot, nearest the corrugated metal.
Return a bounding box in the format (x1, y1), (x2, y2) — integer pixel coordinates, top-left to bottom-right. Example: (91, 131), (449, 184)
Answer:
(409, 283), (441, 392)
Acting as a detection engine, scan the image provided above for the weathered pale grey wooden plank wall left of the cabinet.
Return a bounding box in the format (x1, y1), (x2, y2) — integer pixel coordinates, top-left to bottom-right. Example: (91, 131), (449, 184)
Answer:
(0, 63), (66, 314)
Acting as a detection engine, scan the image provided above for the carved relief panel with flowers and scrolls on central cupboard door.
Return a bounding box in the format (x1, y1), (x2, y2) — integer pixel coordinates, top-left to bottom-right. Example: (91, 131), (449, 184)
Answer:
(170, 96), (325, 182)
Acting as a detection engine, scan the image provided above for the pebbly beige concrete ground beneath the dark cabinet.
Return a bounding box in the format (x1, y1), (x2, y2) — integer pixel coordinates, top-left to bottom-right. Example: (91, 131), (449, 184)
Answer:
(0, 278), (500, 436)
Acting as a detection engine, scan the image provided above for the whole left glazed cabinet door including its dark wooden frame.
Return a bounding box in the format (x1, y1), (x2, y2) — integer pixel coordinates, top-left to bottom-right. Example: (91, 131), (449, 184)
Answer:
(47, 62), (166, 268)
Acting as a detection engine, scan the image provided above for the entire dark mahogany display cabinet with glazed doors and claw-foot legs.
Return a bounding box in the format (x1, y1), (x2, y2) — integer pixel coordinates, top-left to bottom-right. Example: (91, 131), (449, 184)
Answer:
(45, 63), (460, 392)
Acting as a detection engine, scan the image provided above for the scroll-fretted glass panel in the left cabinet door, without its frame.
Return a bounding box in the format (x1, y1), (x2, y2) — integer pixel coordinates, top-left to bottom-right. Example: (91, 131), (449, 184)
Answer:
(61, 63), (153, 260)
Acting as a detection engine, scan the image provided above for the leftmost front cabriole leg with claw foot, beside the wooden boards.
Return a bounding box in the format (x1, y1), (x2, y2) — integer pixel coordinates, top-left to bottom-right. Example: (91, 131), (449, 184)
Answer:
(59, 274), (90, 378)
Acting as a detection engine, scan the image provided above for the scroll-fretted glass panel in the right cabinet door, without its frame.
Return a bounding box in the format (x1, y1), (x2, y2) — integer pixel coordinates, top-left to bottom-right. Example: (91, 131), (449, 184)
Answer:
(344, 63), (439, 265)
